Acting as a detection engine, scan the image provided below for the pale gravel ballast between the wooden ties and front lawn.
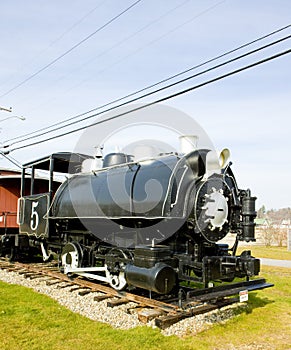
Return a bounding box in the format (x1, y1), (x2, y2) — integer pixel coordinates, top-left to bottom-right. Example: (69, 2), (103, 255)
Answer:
(0, 269), (247, 337)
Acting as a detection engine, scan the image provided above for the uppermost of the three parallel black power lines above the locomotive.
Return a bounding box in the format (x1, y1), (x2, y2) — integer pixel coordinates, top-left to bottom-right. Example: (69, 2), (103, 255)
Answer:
(3, 24), (291, 147)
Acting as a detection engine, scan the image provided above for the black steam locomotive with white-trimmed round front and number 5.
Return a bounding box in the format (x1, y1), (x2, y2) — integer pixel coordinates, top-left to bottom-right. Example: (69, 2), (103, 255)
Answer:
(1, 145), (260, 294)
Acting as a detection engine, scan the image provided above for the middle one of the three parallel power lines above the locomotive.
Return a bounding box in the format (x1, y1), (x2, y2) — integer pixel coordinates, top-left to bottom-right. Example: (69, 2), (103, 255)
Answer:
(3, 31), (291, 148)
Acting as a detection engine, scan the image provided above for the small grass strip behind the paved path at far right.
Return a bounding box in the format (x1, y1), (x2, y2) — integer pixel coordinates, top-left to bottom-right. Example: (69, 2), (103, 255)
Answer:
(238, 245), (291, 260)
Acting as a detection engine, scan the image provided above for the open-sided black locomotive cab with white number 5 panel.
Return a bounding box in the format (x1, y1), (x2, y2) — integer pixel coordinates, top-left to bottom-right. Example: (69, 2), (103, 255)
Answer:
(16, 152), (92, 260)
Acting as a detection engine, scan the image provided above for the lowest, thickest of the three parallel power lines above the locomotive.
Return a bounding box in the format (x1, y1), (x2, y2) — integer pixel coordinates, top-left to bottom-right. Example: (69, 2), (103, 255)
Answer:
(4, 49), (291, 154)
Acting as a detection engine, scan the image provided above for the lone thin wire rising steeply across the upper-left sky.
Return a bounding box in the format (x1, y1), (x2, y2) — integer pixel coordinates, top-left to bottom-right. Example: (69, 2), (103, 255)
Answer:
(0, 0), (142, 98)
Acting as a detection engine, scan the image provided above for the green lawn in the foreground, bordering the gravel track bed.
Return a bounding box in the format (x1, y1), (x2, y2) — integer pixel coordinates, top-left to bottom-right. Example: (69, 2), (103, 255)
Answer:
(0, 267), (291, 350)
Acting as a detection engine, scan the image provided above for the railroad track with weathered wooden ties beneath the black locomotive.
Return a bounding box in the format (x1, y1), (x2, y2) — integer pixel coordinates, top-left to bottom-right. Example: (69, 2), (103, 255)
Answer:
(0, 259), (273, 329)
